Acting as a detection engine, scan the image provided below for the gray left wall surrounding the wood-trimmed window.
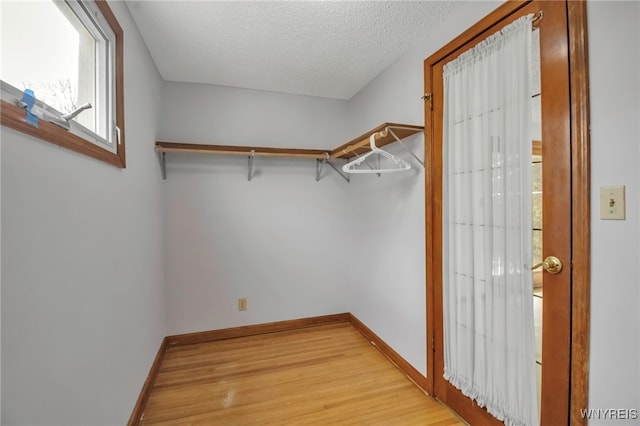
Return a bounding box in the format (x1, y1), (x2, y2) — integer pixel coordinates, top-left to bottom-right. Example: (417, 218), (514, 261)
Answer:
(0, 2), (166, 425)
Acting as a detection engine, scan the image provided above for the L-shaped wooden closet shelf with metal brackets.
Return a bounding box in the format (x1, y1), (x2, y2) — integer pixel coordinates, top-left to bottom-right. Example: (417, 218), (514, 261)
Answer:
(156, 123), (424, 181)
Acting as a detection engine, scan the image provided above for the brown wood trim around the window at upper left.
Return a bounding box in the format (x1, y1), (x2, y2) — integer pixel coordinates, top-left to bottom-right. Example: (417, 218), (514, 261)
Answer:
(0, 0), (126, 168)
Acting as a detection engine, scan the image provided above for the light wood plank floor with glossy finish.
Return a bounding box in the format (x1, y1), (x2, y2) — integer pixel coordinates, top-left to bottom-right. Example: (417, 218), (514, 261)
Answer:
(141, 323), (464, 425)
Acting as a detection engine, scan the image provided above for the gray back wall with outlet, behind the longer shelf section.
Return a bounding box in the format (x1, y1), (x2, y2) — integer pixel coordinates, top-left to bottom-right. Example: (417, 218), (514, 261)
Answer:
(161, 83), (350, 334)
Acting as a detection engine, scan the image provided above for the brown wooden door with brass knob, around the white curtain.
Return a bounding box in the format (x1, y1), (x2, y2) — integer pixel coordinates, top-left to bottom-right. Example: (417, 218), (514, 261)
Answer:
(425, 1), (571, 425)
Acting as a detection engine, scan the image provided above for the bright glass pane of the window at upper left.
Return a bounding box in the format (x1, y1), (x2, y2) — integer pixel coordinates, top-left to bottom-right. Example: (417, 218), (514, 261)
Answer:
(0, 1), (96, 133)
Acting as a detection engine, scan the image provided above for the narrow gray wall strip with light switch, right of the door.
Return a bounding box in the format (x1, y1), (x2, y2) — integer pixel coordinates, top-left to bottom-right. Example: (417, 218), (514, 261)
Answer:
(587, 1), (640, 425)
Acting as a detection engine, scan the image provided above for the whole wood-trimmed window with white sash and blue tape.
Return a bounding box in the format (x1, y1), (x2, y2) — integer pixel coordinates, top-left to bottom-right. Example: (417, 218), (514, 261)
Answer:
(0, 0), (125, 167)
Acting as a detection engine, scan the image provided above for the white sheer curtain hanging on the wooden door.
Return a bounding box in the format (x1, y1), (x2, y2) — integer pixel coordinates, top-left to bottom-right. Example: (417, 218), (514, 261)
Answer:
(443, 16), (538, 425)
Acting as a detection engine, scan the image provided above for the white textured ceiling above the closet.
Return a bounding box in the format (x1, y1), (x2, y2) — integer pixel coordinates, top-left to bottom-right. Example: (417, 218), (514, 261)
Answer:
(126, 0), (454, 99)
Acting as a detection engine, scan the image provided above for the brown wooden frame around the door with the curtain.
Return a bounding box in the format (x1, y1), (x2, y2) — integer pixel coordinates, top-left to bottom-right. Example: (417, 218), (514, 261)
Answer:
(424, 0), (591, 425)
